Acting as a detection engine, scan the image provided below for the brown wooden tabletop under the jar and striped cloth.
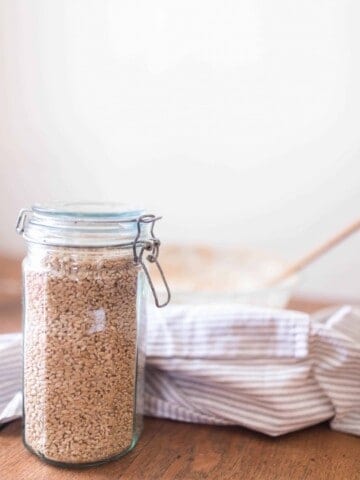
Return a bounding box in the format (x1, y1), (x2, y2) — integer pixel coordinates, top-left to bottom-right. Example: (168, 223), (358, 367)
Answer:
(0, 261), (360, 480)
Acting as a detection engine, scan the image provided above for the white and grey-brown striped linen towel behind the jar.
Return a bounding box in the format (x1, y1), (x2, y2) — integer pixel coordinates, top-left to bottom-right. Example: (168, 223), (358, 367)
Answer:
(0, 305), (360, 436)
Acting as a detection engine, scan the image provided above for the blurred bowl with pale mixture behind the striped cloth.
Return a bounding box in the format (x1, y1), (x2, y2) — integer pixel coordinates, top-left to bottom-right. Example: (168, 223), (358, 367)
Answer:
(156, 245), (299, 308)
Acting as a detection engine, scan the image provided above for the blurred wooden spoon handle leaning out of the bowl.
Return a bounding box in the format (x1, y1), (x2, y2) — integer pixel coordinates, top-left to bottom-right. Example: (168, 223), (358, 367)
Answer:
(268, 218), (360, 286)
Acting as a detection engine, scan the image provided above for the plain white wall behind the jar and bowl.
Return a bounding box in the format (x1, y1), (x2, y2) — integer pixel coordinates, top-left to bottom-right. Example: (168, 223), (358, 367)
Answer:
(0, 0), (360, 299)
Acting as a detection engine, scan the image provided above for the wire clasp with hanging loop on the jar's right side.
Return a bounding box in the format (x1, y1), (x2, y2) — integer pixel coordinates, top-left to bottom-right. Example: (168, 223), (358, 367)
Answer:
(133, 214), (171, 308)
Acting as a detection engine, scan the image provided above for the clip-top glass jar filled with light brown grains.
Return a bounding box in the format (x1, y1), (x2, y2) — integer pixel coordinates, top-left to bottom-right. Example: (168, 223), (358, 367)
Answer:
(17, 204), (170, 466)
